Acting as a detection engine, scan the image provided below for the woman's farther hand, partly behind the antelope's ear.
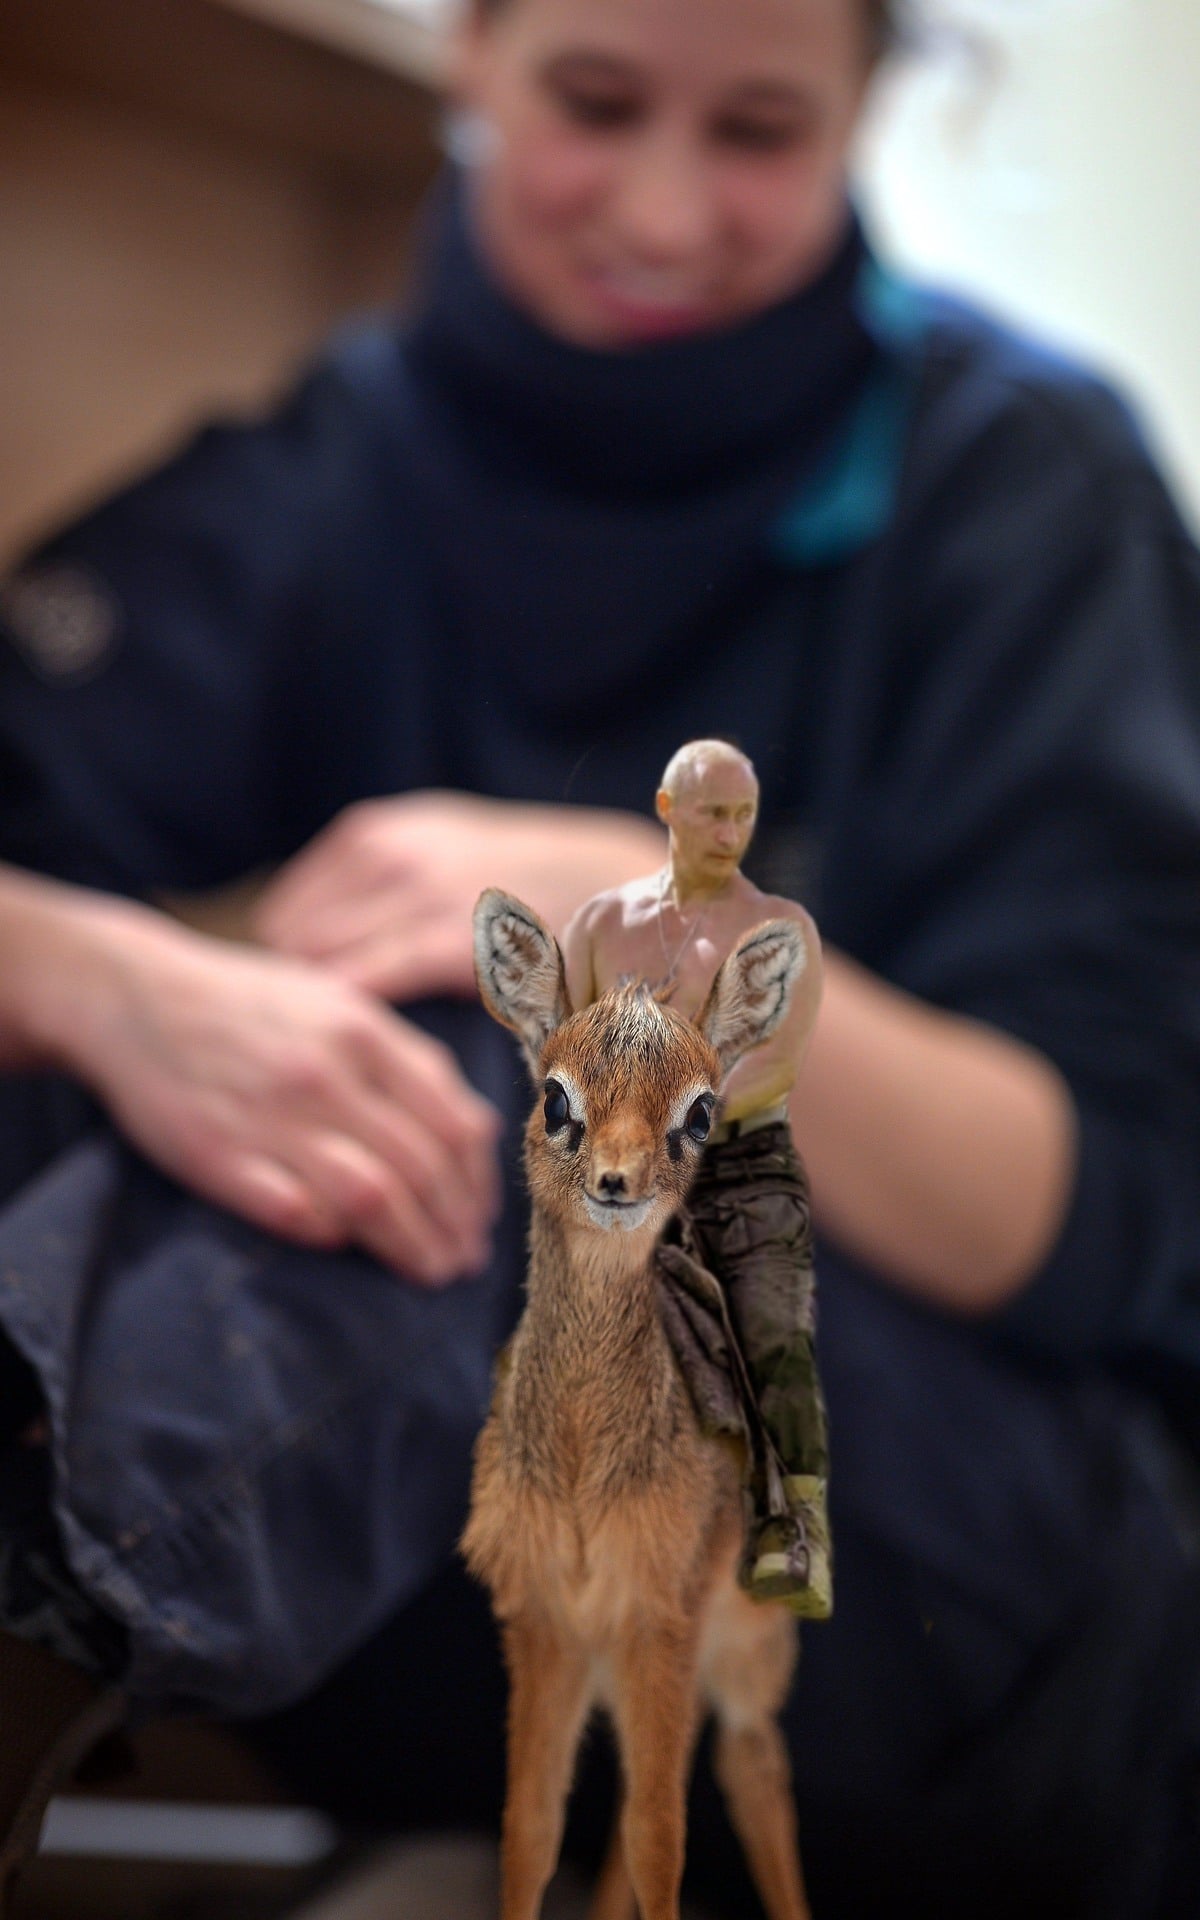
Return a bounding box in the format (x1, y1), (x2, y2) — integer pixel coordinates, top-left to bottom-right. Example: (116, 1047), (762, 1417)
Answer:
(253, 793), (664, 1000)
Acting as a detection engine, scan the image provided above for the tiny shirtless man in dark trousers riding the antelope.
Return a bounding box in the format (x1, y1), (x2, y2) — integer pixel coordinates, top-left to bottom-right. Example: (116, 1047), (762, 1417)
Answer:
(563, 739), (833, 1619)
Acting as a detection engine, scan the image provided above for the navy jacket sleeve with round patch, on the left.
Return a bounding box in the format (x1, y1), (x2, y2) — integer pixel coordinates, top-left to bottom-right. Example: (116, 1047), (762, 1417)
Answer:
(0, 365), (370, 893)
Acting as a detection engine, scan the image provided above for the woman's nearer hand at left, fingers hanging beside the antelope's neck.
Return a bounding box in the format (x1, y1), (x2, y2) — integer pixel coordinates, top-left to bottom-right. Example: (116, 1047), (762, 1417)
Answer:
(0, 876), (497, 1284)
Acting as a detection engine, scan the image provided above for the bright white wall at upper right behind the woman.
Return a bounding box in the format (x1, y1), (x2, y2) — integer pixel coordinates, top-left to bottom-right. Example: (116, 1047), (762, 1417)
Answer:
(862, 0), (1200, 524)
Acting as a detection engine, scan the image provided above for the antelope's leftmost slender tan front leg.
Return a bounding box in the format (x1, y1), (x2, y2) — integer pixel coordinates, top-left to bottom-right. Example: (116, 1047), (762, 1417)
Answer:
(501, 1620), (589, 1920)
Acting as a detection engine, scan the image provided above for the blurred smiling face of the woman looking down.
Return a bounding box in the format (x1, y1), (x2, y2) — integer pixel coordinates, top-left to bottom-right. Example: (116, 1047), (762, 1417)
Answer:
(455, 0), (872, 348)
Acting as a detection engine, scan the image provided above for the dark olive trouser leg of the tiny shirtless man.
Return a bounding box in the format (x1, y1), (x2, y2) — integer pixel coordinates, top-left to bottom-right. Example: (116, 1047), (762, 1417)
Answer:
(682, 1121), (829, 1480)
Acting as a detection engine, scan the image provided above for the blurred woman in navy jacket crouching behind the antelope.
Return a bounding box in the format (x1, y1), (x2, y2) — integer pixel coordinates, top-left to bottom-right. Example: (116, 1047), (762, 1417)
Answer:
(0, 0), (1200, 1920)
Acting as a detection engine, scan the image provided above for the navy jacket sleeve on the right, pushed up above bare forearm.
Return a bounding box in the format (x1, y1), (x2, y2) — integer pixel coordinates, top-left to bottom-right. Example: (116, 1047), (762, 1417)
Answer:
(851, 349), (1200, 1377)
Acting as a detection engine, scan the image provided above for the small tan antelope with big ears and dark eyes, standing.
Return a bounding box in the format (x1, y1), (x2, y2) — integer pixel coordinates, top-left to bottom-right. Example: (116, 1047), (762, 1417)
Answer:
(463, 893), (808, 1920)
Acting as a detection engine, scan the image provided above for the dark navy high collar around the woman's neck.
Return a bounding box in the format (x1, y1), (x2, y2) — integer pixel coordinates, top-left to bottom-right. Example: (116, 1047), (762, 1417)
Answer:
(409, 177), (872, 501)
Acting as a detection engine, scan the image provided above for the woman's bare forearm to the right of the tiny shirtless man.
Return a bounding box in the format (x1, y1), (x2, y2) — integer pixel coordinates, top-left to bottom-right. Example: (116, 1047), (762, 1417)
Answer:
(793, 948), (1077, 1313)
